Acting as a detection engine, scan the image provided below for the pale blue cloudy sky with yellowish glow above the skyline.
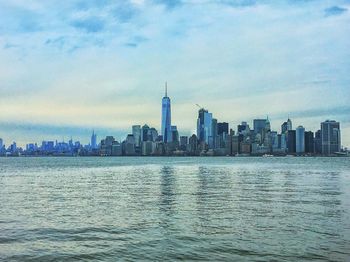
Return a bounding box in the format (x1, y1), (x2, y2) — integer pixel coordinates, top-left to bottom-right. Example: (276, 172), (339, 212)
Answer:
(0, 0), (350, 147)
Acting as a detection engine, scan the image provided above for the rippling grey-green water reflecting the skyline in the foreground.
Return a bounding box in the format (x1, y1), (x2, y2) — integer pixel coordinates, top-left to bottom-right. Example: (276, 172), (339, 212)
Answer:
(0, 157), (350, 261)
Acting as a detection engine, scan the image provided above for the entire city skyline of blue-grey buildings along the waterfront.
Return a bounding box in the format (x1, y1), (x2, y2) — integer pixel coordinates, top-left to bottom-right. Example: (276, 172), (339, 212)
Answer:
(0, 87), (348, 156)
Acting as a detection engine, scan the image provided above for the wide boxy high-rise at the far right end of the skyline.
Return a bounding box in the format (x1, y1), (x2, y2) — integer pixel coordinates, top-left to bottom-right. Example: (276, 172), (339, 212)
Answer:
(321, 120), (340, 155)
